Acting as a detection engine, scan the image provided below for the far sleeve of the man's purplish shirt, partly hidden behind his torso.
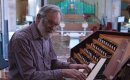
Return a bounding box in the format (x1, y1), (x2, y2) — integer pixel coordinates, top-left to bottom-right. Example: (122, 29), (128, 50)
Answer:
(50, 40), (70, 69)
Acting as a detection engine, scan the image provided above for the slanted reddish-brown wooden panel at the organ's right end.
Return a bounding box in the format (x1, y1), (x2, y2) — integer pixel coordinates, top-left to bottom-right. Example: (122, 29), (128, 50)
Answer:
(104, 40), (128, 80)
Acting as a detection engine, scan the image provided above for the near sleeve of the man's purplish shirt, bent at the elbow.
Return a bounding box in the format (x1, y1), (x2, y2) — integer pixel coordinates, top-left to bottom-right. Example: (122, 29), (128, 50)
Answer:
(13, 39), (62, 80)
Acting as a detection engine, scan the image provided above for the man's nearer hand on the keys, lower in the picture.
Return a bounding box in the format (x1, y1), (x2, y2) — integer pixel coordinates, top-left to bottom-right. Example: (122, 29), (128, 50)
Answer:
(62, 69), (87, 80)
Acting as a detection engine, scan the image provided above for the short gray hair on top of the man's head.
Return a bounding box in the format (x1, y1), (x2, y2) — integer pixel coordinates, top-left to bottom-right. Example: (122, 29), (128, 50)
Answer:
(38, 5), (62, 18)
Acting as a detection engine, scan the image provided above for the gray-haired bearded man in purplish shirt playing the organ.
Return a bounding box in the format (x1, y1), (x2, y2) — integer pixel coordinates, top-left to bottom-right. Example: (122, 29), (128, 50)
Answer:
(9, 5), (90, 80)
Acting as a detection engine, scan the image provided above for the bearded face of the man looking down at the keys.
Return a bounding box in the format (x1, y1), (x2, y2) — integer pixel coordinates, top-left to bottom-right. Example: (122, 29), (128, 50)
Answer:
(44, 12), (61, 33)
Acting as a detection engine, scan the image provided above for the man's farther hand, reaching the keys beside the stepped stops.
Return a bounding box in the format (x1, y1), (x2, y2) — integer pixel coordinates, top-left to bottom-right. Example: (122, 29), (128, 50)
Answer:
(69, 64), (91, 73)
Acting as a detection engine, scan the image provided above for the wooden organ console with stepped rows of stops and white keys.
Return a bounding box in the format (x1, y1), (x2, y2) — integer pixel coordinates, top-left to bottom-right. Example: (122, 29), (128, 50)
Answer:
(70, 31), (130, 80)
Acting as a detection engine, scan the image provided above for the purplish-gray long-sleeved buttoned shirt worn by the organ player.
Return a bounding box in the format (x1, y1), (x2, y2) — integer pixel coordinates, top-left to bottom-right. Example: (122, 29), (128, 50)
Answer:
(8, 23), (69, 80)
